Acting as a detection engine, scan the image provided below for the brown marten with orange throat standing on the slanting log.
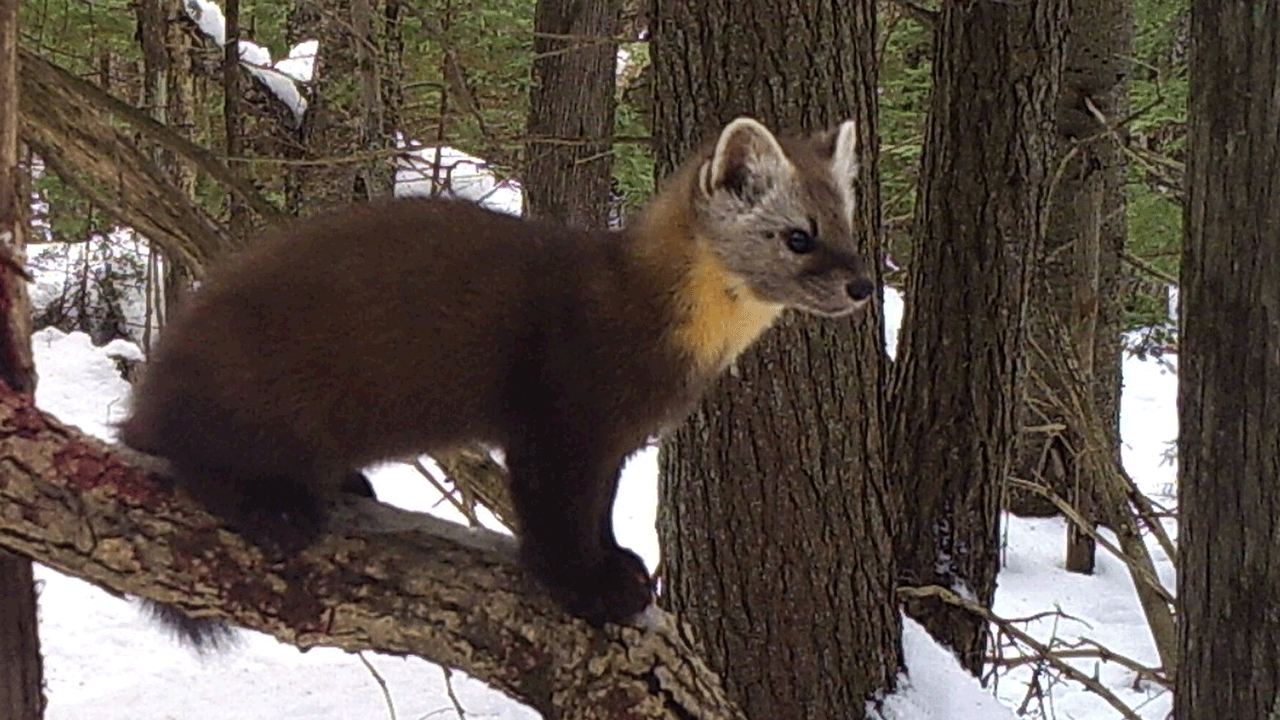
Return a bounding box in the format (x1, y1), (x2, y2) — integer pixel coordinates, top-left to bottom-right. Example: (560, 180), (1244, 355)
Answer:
(120, 118), (877, 643)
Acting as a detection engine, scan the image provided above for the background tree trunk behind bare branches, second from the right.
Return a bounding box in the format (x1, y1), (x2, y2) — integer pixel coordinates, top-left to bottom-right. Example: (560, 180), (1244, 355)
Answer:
(1009, 0), (1133, 573)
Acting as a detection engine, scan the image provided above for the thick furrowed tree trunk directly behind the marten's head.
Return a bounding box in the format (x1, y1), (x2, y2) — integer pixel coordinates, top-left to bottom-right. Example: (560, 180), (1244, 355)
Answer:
(652, 0), (901, 719)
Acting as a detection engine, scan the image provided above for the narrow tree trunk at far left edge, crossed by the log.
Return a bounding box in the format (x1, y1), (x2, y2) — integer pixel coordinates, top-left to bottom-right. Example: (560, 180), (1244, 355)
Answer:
(0, 0), (45, 720)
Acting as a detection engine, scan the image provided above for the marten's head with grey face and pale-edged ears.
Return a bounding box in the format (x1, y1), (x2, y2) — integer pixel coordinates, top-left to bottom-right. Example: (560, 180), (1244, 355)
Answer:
(694, 118), (874, 315)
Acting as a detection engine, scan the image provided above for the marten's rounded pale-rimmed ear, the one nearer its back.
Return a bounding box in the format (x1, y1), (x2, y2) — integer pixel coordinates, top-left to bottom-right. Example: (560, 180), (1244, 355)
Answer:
(700, 118), (796, 202)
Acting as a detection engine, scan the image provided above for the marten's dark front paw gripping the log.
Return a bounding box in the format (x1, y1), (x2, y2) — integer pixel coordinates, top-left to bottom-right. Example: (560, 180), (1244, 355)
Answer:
(534, 547), (653, 628)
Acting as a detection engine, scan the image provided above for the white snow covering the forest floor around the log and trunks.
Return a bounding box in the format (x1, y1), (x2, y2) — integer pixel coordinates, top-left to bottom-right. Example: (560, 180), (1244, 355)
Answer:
(24, 293), (1176, 720)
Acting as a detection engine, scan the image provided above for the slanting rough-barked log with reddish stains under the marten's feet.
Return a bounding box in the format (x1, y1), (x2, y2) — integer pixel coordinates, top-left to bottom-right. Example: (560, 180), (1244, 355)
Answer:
(0, 387), (742, 720)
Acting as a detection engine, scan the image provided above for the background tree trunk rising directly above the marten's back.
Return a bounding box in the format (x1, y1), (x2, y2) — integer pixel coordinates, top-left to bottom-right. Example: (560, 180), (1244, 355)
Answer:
(522, 0), (622, 228)
